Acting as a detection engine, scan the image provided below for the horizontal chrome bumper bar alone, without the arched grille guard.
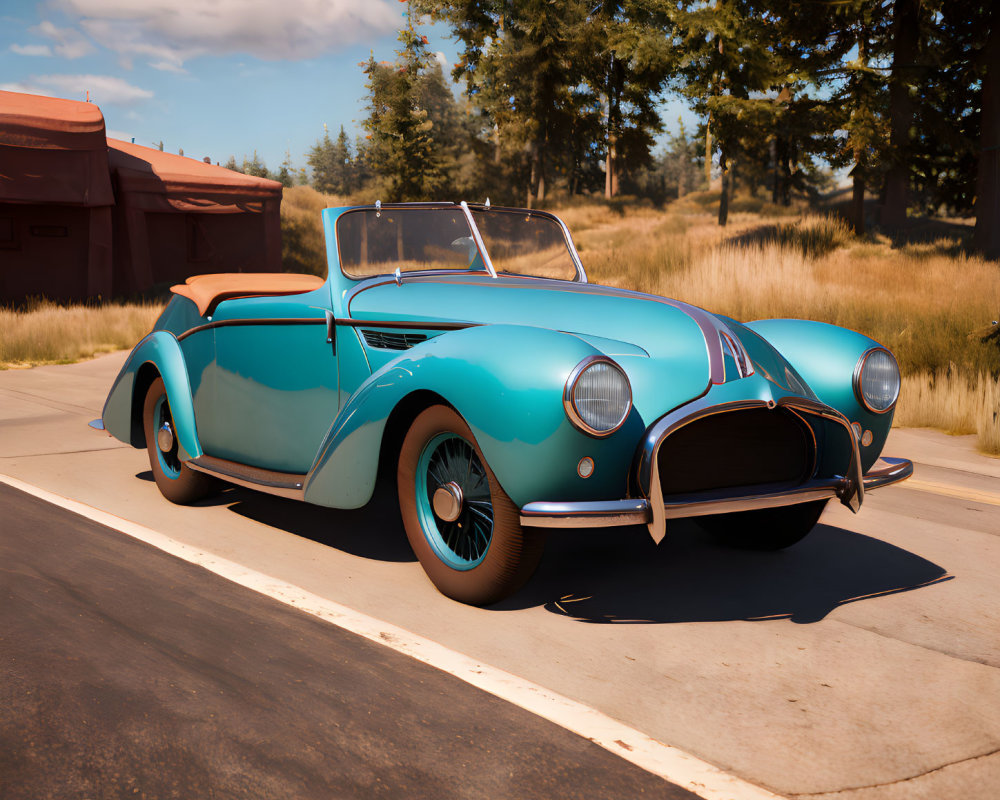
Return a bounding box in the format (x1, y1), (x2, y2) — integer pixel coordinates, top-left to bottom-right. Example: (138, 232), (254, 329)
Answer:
(521, 457), (913, 541)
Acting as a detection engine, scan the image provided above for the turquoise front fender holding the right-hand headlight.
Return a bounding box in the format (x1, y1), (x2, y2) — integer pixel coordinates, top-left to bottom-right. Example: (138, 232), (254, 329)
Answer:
(746, 319), (893, 471)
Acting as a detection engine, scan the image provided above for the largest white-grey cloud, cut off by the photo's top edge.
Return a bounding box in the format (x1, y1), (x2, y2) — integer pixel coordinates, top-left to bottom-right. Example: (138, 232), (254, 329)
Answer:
(56, 0), (401, 69)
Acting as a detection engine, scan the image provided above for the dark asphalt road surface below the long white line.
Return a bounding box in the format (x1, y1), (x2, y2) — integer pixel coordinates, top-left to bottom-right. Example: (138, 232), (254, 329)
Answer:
(0, 485), (694, 800)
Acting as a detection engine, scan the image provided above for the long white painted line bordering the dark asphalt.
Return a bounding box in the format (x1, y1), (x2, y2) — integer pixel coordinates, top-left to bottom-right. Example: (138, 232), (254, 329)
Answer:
(0, 474), (782, 800)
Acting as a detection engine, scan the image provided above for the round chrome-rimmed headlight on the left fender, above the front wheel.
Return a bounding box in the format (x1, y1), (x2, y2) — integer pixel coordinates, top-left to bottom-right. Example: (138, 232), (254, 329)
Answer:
(563, 356), (632, 436)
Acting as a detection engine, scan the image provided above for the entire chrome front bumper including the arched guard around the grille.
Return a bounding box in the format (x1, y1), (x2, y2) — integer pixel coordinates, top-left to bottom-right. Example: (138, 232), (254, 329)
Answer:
(520, 396), (913, 542)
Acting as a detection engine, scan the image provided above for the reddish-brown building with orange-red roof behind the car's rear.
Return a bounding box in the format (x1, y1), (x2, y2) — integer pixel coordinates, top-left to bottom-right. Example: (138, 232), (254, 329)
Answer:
(0, 91), (282, 305)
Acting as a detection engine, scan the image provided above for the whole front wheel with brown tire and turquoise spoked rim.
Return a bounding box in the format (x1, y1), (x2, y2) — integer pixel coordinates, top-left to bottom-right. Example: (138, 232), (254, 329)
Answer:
(396, 406), (544, 606)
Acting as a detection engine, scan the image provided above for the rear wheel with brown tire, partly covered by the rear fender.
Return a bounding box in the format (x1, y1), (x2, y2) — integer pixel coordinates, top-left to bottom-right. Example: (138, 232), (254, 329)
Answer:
(142, 378), (217, 505)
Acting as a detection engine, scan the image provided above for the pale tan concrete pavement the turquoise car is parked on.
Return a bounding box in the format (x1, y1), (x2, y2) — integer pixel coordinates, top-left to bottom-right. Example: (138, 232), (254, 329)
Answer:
(0, 354), (1000, 800)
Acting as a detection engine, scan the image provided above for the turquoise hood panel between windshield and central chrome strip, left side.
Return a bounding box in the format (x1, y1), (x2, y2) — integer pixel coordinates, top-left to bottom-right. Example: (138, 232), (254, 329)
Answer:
(349, 276), (722, 421)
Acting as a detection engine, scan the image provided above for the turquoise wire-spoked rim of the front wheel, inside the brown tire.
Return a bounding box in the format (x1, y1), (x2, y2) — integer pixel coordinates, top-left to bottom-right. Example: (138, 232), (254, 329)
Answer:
(416, 433), (493, 570)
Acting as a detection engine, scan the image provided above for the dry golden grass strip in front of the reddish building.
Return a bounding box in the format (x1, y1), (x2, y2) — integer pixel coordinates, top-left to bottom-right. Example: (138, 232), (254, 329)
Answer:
(0, 300), (163, 369)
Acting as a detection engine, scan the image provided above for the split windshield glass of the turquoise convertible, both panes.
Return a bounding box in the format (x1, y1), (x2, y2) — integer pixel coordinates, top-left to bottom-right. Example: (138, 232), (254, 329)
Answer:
(337, 205), (577, 280)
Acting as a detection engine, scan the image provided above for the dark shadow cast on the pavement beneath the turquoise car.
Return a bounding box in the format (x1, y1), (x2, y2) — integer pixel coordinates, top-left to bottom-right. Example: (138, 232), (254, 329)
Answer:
(136, 472), (952, 624)
